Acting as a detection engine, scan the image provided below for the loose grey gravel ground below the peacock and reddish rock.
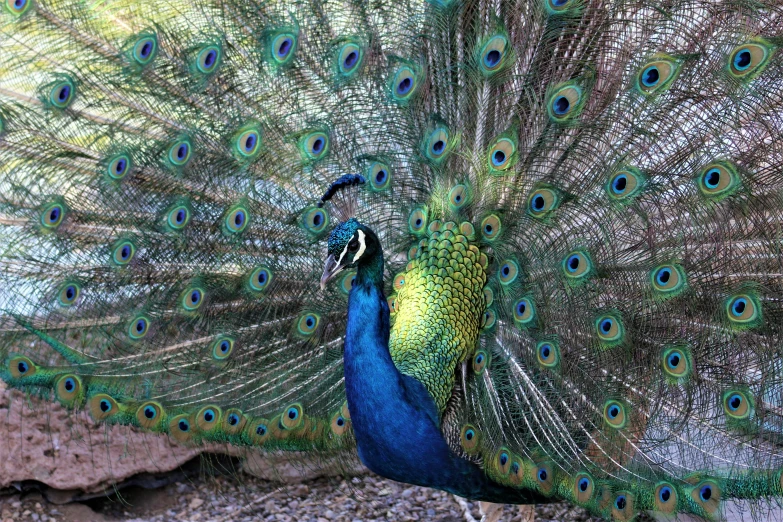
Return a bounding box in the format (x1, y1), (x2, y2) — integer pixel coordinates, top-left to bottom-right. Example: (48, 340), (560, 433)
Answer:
(0, 475), (656, 522)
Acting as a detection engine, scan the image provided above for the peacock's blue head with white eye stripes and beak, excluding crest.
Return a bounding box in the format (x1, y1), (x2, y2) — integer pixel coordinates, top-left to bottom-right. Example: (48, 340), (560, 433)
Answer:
(321, 218), (380, 290)
